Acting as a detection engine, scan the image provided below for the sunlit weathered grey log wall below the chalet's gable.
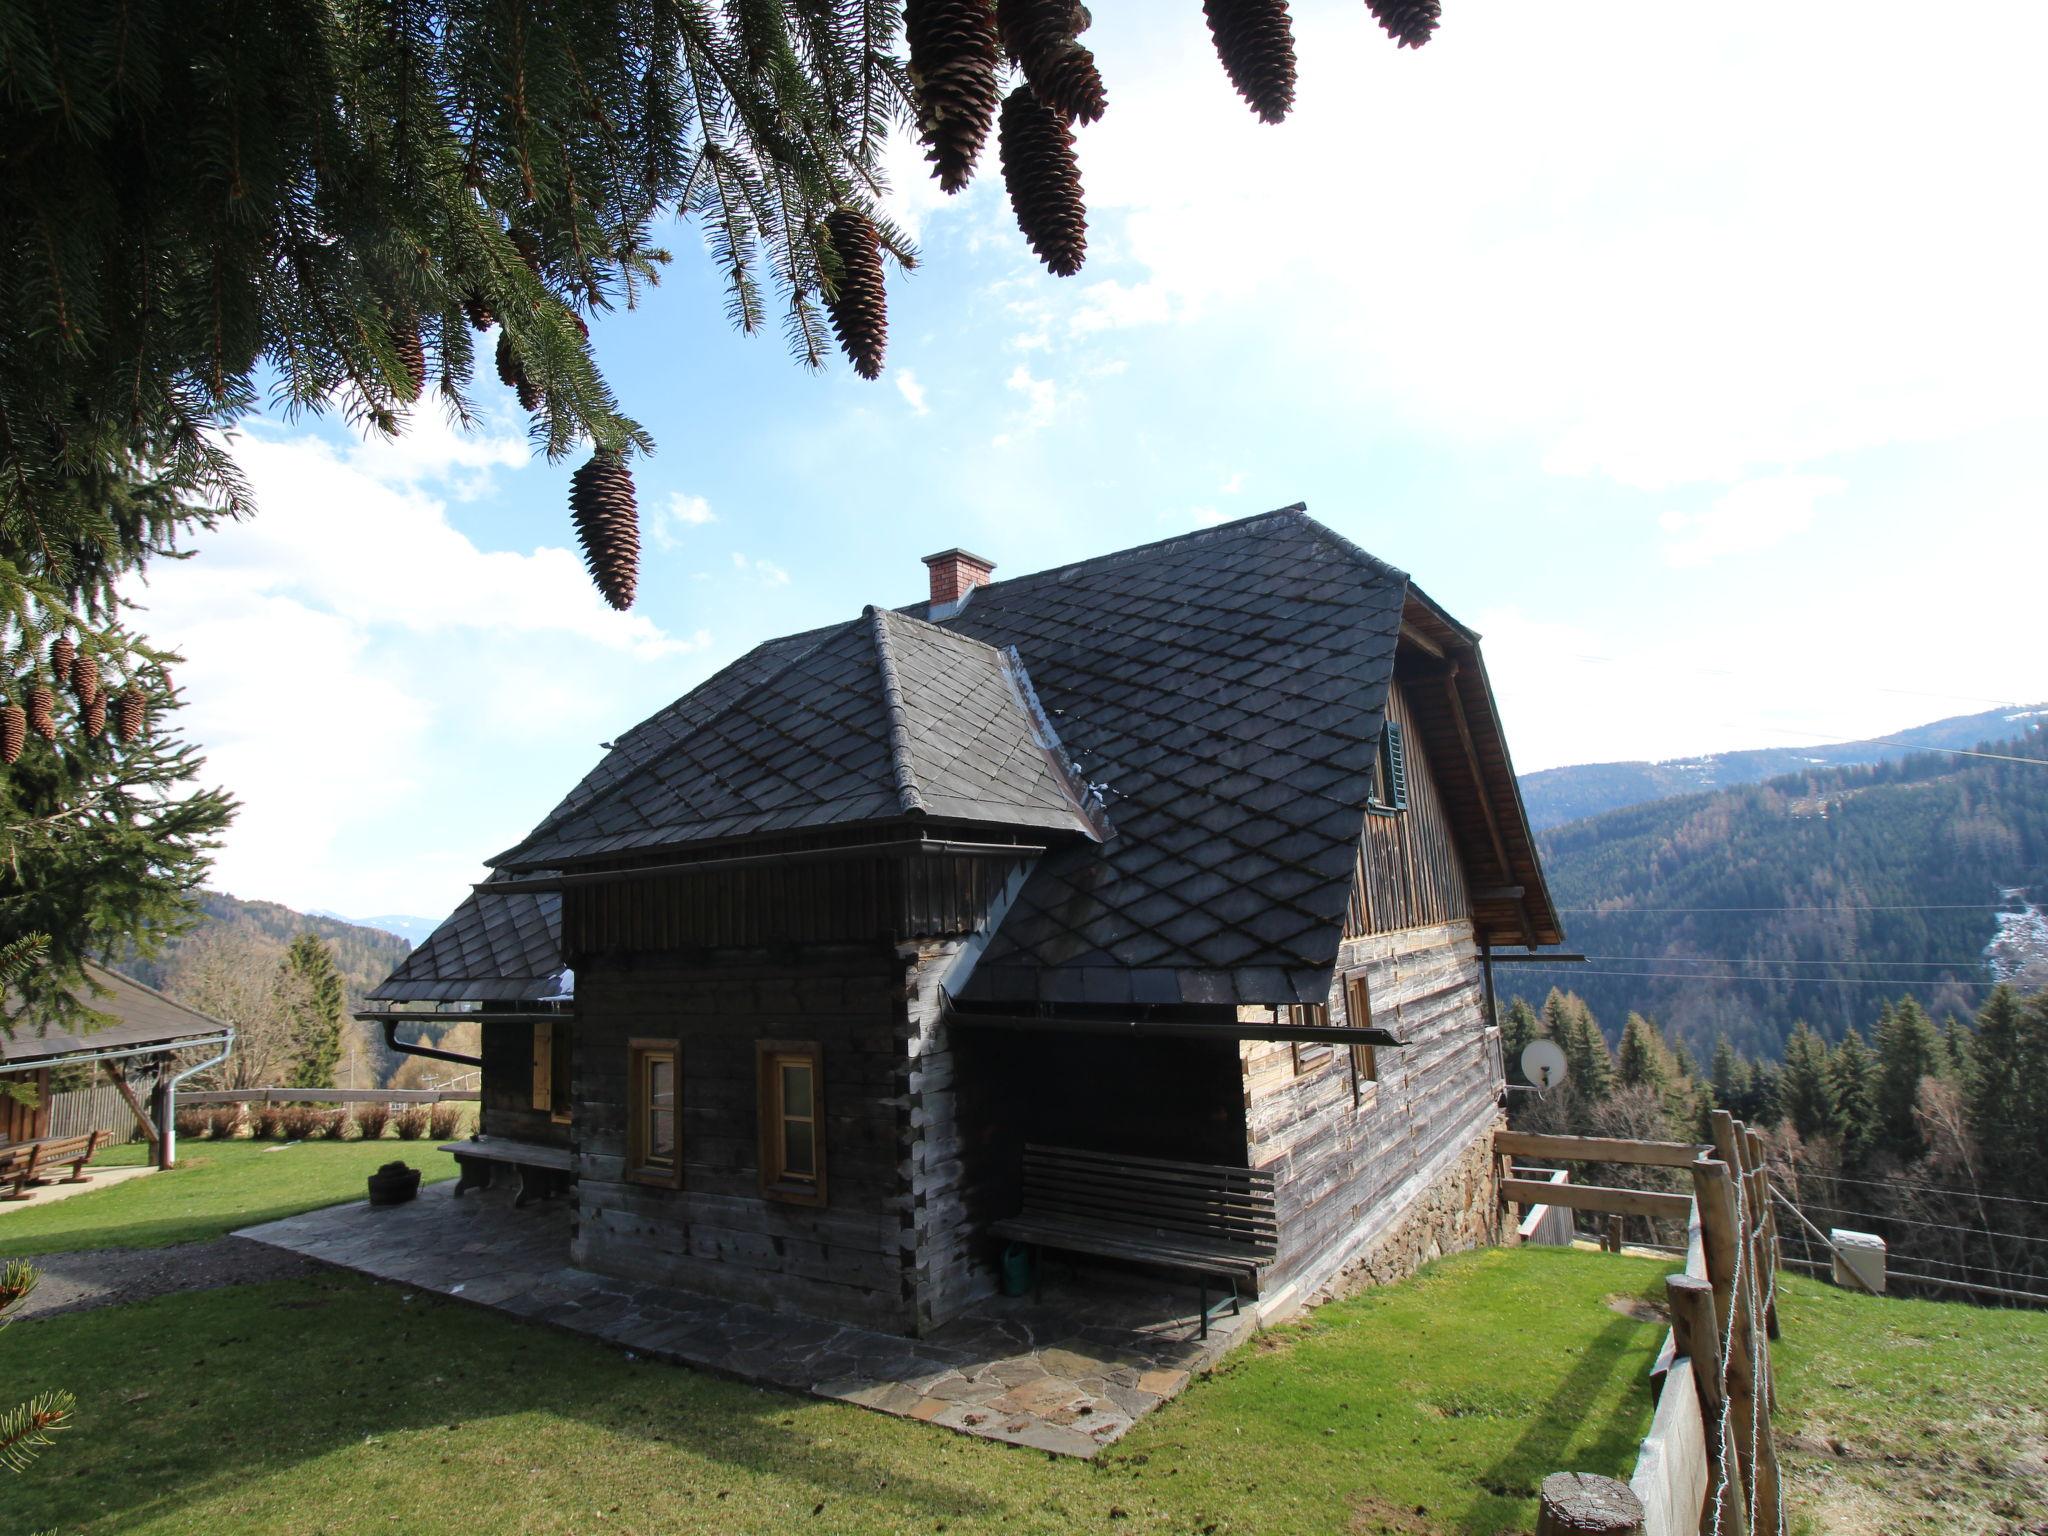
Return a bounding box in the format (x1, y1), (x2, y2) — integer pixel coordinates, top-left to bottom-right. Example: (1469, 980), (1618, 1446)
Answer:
(1239, 920), (1499, 1294)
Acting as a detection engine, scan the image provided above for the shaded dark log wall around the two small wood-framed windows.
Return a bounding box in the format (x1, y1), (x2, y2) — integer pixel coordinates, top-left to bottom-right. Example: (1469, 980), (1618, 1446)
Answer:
(571, 944), (946, 1333)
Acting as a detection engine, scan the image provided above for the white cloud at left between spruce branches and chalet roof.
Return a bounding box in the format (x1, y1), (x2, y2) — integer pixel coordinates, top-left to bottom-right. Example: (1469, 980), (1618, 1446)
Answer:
(127, 428), (711, 911)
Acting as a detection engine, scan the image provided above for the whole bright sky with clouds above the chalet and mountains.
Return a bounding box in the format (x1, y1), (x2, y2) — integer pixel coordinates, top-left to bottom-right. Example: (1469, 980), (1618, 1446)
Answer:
(123, 0), (2048, 913)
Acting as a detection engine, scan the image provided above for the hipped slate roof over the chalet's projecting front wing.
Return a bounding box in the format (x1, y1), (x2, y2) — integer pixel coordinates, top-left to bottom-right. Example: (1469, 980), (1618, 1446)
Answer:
(494, 608), (1096, 870)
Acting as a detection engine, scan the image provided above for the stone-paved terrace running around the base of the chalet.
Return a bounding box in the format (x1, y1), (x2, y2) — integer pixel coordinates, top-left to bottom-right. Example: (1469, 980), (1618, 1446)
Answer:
(238, 1180), (1255, 1456)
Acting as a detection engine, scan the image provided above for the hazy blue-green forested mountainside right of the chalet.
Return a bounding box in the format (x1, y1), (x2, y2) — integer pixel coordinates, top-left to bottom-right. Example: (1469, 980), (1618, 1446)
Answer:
(1540, 727), (2048, 1061)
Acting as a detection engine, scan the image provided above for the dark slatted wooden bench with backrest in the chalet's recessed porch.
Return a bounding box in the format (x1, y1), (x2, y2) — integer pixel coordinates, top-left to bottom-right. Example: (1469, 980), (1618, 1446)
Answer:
(989, 1147), (1280, 1339)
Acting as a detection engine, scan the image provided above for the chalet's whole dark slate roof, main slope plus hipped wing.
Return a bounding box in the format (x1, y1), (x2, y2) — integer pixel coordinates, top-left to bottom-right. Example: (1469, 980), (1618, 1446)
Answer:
(458, 506), (1407, 1004)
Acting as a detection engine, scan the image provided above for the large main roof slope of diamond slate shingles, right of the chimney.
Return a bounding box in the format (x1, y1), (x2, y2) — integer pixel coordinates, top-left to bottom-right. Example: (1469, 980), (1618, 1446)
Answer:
(913, 508), (1407, 1004)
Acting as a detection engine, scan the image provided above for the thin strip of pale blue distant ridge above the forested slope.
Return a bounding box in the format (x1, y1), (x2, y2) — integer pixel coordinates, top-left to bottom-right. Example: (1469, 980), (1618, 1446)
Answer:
(1520, 705), (2048, 831)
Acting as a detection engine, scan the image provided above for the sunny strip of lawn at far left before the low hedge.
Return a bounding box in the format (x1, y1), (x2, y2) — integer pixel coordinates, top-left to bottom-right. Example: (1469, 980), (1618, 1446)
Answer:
(0, 1139), (455, 1257)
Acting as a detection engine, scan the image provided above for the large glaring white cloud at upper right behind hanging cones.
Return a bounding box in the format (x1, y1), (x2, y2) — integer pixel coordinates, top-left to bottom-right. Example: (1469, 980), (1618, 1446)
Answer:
(1047, 0), (2048, 492)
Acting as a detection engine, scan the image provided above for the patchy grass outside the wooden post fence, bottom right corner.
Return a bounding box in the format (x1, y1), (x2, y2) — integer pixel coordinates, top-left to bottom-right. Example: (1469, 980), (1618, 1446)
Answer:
(1772, 1276), (2048, 1536)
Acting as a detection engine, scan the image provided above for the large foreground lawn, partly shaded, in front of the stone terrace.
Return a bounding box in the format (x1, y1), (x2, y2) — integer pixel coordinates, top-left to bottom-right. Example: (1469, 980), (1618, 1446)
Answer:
(0, 1253), (1667, 1536)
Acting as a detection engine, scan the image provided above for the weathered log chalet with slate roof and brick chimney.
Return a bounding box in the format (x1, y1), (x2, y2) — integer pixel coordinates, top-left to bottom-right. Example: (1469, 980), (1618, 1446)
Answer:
(373, 506), (1563, 1333)
